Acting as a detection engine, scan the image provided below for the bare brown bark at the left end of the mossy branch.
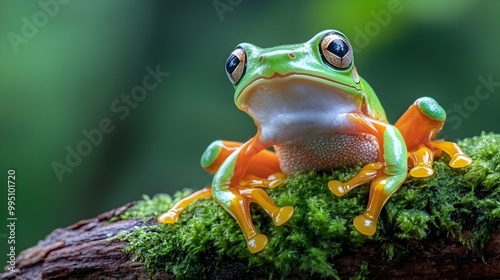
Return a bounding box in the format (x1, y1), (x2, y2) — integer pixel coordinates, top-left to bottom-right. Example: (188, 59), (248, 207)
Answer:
(1, 203), (172, 280)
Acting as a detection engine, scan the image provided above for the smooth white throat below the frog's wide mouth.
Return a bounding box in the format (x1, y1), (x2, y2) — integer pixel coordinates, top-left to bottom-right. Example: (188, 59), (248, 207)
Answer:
(238, 75), (363, 145)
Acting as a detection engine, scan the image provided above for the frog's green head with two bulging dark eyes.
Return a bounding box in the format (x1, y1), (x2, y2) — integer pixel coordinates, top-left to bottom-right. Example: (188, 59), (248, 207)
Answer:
(226, 30), (383, 124)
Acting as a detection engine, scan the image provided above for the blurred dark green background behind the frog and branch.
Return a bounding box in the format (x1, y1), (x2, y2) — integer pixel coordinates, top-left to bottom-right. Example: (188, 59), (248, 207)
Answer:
(0, 0), (500, 266)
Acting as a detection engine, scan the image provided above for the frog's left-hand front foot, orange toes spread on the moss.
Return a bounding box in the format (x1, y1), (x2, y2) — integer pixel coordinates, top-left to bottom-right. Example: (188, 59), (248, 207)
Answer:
(214, 186), (294, 253)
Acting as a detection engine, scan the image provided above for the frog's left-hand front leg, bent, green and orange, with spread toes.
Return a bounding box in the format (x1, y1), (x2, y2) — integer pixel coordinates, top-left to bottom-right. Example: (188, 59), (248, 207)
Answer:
(212, 136), (294, 253)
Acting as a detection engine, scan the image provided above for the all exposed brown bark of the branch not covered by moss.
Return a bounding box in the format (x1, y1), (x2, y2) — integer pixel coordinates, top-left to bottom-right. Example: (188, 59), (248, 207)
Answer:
(0, 203), (500, 280)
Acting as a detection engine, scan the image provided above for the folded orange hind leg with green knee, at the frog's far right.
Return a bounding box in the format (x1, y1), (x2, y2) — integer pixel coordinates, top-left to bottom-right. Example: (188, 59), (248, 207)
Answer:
(395, 97), (472, 177)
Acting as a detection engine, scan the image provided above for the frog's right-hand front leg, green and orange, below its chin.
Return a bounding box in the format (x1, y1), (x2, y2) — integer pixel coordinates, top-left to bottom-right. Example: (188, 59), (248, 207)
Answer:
(328, 114), (407, 236)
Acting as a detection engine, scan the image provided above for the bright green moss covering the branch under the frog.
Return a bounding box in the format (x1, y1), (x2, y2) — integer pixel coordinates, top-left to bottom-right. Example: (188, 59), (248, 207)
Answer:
(120, 134), (500, 279)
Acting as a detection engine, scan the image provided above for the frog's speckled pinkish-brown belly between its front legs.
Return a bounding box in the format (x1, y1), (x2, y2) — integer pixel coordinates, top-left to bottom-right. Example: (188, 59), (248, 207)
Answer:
(274, 134), (379, 174)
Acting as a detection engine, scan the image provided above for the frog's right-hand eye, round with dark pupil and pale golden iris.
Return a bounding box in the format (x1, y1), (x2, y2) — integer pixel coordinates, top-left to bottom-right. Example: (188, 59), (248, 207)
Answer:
(319, 32), (353, 69)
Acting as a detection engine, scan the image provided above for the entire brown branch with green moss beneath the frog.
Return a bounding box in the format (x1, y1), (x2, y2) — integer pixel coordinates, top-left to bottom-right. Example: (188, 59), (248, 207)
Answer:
(2, 134), (500, 279)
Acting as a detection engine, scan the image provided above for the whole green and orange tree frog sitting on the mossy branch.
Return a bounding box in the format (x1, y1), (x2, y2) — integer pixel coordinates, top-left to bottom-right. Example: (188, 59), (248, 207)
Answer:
(158, 30), (471, 253)
